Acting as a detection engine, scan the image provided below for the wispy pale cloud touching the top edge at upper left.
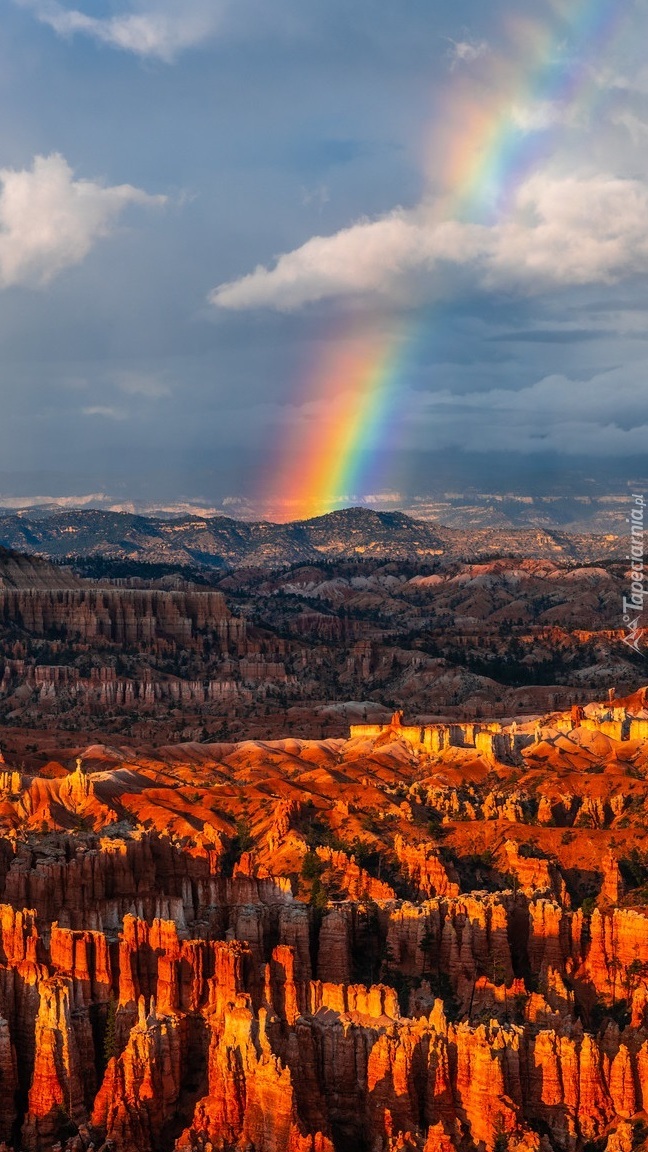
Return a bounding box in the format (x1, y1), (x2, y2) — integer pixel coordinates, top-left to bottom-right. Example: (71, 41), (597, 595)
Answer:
(16, 0), (225, 63)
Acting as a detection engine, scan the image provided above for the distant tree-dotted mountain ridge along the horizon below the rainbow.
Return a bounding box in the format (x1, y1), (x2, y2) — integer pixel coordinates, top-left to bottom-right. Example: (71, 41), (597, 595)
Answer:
(0, 508), (626, 569)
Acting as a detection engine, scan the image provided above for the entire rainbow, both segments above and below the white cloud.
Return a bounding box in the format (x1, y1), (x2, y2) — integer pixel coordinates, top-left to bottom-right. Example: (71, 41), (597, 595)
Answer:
(268, 0), (630, 520)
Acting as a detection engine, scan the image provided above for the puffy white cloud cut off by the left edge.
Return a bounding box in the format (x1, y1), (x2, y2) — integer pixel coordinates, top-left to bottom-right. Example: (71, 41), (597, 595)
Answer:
(0, 153), (165, 288)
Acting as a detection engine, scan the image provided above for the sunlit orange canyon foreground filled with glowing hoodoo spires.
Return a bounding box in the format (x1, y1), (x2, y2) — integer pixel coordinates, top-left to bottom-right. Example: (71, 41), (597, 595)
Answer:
(0, 689), (648, 1152)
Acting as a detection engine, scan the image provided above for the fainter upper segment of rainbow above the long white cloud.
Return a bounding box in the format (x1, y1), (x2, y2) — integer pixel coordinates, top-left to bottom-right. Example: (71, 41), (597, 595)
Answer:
(427, 0), (627, 219)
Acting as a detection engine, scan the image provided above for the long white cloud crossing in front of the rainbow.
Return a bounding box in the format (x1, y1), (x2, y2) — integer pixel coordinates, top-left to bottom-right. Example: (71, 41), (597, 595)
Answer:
(210, 173), (648, 310)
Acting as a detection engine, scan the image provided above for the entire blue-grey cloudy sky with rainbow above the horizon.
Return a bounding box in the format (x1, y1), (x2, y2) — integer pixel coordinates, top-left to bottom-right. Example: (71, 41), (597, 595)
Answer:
(0, 0), (648, 518)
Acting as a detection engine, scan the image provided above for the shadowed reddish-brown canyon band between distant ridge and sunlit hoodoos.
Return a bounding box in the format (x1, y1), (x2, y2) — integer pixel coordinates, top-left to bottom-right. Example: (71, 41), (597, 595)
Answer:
(0, 539), (641, 741)
